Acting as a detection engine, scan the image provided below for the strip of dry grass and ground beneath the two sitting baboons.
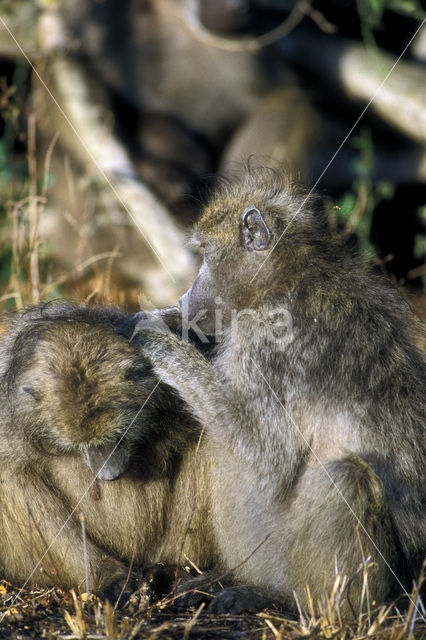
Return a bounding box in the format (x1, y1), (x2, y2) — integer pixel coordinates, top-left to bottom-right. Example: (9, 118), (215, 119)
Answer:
(0, 563), (426, 640)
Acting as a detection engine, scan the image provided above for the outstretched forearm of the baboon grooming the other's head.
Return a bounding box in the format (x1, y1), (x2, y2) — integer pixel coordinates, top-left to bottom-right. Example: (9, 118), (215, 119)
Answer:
(141, 329), (307, 492)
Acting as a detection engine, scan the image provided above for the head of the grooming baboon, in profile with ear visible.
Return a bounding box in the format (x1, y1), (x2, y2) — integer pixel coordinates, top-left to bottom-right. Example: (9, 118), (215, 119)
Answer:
(179, 167), (328, 332)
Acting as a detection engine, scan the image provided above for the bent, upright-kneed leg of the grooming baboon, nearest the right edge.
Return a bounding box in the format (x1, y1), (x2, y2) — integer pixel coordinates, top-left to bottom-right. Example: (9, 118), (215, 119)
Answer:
(285, 455), (396, 612)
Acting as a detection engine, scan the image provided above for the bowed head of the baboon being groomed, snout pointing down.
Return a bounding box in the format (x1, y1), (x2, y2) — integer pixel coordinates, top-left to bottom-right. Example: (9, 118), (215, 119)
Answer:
(4, 304), (161, 480)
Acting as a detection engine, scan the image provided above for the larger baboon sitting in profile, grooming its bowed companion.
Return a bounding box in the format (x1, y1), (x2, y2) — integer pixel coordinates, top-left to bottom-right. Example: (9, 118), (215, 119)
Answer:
(139, 166), (426, 613)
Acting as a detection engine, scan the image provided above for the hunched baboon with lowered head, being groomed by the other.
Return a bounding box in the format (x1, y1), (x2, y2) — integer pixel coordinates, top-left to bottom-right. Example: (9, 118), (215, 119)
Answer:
(0, 302), (212, 596)
